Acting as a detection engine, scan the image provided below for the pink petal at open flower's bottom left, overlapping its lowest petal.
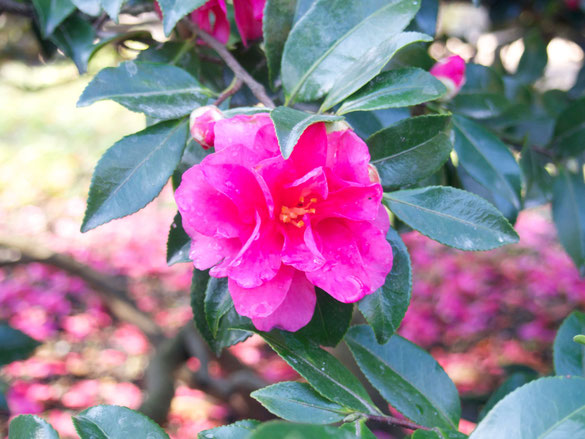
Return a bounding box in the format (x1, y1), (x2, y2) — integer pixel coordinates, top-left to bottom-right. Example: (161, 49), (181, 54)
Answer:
(228, 265), (295, 319)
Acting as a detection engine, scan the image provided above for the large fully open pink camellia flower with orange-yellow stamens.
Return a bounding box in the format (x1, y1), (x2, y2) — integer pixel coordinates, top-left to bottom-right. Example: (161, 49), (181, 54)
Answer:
(175, 113), (392, 331)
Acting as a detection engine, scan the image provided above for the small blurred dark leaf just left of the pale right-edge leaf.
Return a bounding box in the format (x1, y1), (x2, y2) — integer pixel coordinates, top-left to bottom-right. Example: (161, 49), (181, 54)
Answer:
(520, 144), (553, 207)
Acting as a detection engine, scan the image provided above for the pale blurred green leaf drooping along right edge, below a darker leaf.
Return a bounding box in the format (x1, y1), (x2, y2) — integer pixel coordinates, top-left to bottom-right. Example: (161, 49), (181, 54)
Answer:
(552, 169), (585, 276)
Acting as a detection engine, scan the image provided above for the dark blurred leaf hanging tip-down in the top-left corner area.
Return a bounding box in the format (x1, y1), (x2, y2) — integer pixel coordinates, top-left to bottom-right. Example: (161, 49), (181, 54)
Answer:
(51, 15), (96, 73)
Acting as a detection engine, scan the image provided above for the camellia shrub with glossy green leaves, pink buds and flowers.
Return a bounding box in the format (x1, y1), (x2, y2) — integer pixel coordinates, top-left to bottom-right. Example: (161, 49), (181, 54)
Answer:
(2, 0), (585, 439)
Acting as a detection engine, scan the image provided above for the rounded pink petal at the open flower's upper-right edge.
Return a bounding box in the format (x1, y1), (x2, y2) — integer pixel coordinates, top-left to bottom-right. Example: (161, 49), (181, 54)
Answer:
(327, 129), (370, 185)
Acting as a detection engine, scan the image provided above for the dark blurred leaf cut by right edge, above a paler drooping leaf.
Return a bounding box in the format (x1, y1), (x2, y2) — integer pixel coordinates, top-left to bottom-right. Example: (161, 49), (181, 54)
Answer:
(554, 98), (585, 157)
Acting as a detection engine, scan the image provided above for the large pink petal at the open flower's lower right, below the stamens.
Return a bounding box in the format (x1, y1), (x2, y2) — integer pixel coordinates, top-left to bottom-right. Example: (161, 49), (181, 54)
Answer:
(307, 219), (373, 303)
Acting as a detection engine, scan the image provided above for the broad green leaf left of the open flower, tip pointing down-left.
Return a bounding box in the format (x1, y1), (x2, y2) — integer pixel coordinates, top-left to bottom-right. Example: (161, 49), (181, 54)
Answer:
(81, 120), (188, 232)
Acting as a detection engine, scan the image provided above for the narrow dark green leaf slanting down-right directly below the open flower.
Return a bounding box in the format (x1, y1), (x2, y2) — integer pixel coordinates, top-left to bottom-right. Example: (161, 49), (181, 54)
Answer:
(260, 332), (379, 413)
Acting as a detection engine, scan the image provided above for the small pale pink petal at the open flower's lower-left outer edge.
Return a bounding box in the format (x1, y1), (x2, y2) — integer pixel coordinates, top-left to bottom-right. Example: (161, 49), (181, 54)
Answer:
(189, 232), (242, 270)
